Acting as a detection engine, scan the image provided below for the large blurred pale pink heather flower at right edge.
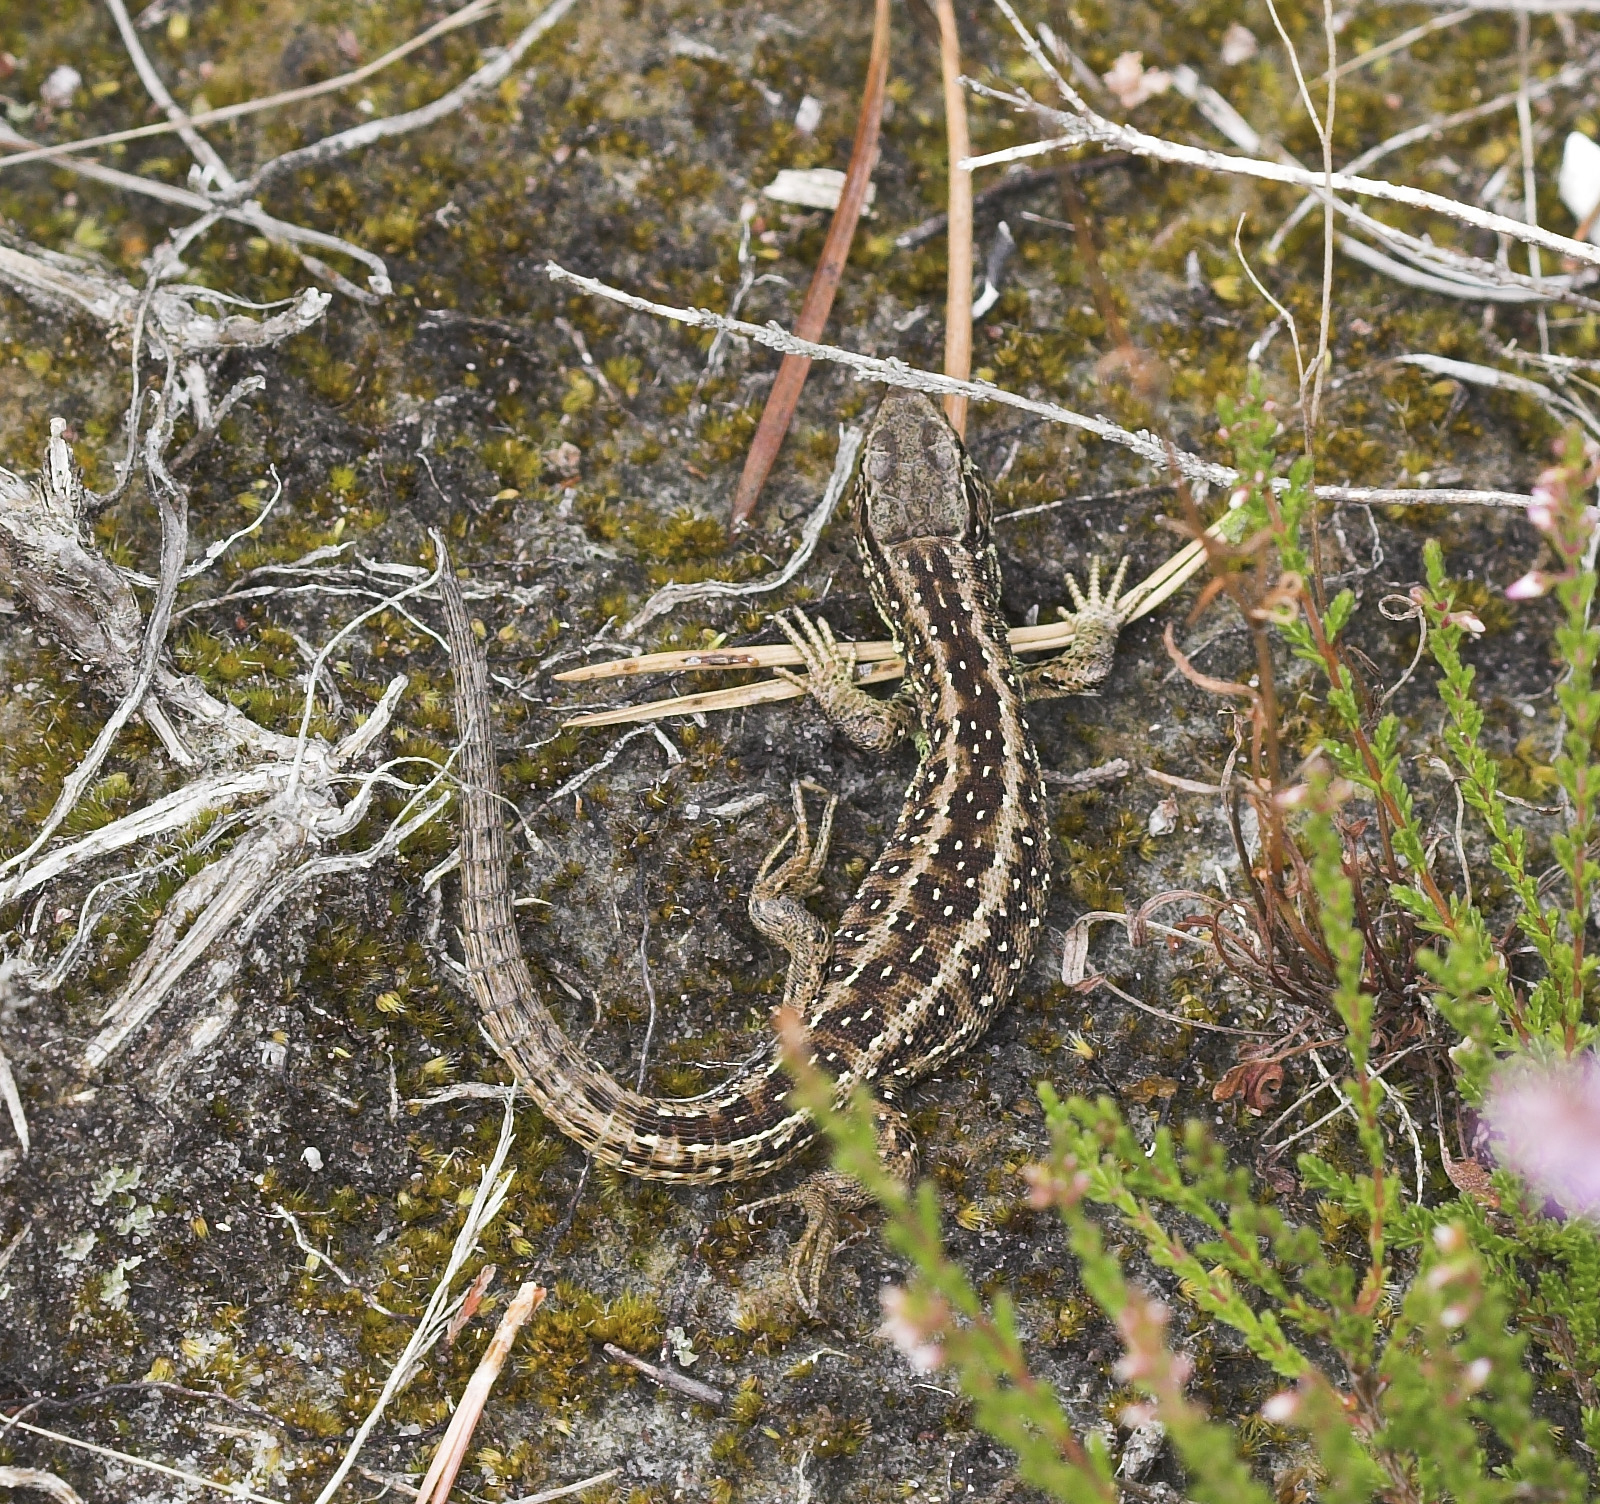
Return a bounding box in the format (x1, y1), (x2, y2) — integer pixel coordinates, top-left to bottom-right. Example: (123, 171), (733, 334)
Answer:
(1483, 1054), (1600, 1221)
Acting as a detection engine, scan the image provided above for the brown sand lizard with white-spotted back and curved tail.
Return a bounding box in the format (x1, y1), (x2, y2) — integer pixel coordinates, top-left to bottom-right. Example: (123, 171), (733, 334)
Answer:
(443, 392), (1126, 1310)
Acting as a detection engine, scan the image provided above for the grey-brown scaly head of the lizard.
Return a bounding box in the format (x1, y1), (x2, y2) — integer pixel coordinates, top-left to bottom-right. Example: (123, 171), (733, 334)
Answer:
(858, 389), (989, 549)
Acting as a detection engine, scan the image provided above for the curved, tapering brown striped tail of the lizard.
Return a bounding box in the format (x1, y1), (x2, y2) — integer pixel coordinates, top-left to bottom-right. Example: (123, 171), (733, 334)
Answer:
(438, 555), (813, 1181)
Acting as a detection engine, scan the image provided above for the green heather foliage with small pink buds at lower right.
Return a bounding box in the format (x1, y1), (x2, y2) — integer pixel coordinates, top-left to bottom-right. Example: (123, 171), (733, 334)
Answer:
(790, 384), (1600, 1504)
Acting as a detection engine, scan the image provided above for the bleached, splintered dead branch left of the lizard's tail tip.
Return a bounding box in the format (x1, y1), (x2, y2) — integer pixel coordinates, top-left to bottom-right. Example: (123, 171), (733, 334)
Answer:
(0, 387), (448, 1072)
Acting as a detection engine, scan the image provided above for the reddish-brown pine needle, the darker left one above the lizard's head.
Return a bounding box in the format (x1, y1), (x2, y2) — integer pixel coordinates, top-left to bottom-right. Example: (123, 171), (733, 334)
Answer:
(730, 0), (890, 531)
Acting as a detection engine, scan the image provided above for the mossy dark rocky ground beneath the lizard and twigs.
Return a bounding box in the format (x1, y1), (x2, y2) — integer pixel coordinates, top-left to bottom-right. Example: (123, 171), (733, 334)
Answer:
(0, 0), (1595, 1504)
